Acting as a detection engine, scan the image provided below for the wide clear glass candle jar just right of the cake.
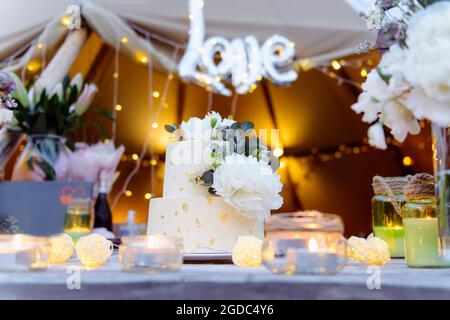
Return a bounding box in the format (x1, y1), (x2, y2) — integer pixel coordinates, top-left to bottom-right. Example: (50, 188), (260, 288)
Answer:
(262, 212), (346, 275)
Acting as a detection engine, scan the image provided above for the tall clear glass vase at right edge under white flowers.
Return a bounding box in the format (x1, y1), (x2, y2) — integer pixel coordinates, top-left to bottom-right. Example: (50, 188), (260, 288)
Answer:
(432, 123), (450, 261)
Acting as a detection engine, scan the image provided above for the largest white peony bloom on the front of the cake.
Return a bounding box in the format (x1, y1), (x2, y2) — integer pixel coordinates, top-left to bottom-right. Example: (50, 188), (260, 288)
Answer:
(212, 153), (283, 221)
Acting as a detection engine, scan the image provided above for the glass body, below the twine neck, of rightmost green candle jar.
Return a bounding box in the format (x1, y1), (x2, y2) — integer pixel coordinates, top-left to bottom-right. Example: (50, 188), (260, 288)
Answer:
(403, 197), (450, 268)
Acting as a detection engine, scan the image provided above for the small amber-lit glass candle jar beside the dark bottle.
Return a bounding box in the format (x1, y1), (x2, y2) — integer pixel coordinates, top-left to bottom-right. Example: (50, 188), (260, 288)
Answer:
(64, 199), (94, 243)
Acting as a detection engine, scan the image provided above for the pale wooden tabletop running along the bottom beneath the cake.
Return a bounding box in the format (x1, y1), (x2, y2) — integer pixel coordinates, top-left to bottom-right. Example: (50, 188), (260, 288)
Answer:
(0, 256), (450, 300)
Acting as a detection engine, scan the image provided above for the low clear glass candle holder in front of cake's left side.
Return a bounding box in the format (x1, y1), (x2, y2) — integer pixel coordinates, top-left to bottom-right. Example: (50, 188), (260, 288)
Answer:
(119, 235), (183, 274)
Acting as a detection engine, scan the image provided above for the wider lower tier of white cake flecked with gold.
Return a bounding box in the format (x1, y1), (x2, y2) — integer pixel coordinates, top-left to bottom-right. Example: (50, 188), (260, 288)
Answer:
(147, 196), (264, 253)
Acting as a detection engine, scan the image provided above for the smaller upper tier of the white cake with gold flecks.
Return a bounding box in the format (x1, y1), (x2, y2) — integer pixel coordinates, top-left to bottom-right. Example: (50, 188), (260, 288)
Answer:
(163, 141), (230, 197)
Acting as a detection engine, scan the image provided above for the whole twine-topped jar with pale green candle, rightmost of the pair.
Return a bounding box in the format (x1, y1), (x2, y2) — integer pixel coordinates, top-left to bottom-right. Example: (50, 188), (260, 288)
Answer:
(402, 173), (450, 268)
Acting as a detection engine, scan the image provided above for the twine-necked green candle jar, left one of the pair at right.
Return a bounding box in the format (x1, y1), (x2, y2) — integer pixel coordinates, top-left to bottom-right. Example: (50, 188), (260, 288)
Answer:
(372, 176), (410, 258)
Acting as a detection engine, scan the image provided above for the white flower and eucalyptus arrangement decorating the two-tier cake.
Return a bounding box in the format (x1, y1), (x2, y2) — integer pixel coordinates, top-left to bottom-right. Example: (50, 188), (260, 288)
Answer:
(166, 112), (283, 220)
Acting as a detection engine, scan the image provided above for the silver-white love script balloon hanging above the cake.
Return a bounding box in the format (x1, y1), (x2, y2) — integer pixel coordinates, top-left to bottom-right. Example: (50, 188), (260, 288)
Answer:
(179, 0), (298, 96)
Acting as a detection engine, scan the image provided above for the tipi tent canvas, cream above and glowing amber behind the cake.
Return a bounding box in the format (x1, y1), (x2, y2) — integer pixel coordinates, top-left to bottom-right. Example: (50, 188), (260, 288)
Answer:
(0, 0), (428, 234)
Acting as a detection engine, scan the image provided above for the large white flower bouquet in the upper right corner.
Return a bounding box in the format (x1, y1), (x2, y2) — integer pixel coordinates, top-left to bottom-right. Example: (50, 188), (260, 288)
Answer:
(352, 0), (450, 149)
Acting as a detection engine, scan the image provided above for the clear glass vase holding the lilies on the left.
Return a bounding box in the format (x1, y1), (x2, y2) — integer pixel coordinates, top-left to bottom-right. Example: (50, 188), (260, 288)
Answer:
(12, 134), (69, 181)
